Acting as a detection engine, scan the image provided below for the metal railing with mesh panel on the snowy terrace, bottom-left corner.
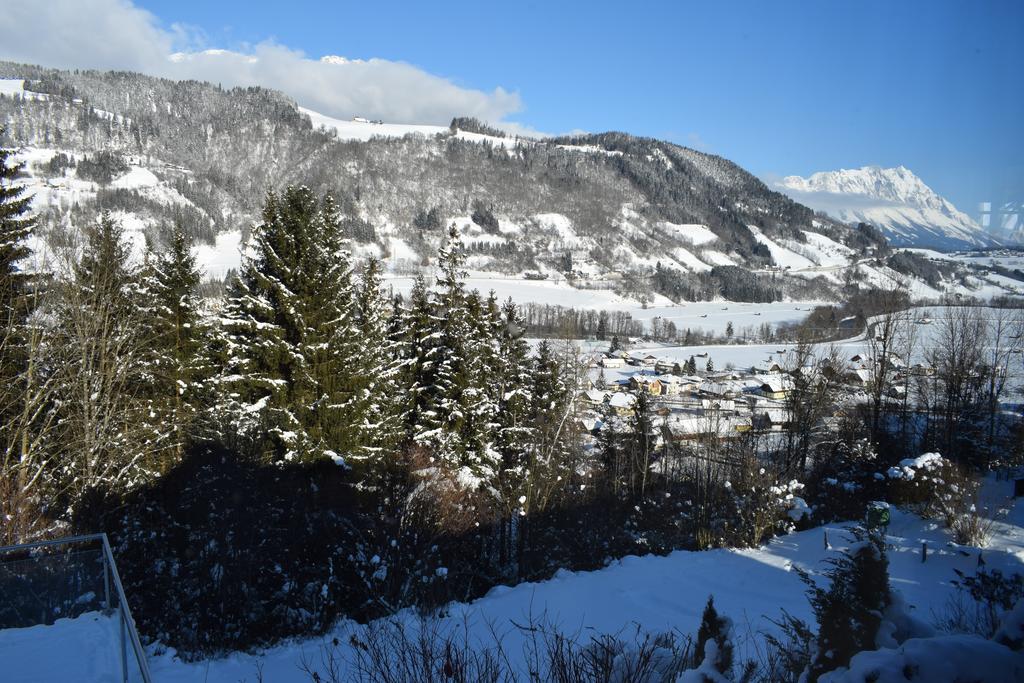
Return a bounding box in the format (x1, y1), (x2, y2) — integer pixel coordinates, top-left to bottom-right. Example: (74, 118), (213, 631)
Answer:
(0, 533), (153, 683)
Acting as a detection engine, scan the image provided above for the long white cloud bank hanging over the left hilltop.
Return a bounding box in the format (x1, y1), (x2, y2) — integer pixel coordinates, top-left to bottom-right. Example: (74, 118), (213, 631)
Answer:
(0, 0), (528, 126)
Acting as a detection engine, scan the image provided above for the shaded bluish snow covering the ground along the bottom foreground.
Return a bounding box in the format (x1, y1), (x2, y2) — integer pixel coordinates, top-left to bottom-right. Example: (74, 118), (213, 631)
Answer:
(0, 482), (1024, 683)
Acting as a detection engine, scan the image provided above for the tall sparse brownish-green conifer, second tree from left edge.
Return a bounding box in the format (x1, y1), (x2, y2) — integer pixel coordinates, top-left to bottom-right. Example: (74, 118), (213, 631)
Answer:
(50, 213), (156, 497)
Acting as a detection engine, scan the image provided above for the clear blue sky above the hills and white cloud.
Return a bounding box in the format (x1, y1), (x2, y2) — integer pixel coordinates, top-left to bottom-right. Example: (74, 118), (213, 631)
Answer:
(0, 0), (1024, 214)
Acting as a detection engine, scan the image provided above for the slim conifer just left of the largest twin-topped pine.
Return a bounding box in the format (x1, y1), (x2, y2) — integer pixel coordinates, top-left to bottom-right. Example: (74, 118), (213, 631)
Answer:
(142, 226), (213, 470)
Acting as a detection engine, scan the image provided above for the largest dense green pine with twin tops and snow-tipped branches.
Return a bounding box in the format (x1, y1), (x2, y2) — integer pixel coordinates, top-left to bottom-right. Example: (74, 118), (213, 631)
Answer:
(223, 187), (365, 461)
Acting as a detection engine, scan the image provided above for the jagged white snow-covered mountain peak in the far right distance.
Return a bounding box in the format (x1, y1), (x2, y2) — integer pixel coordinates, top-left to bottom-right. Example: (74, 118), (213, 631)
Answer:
(777, 166), (998, 250)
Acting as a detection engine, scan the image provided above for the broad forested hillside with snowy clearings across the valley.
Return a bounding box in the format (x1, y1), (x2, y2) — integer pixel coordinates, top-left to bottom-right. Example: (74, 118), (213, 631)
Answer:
(0, 62), (1007, 301)
